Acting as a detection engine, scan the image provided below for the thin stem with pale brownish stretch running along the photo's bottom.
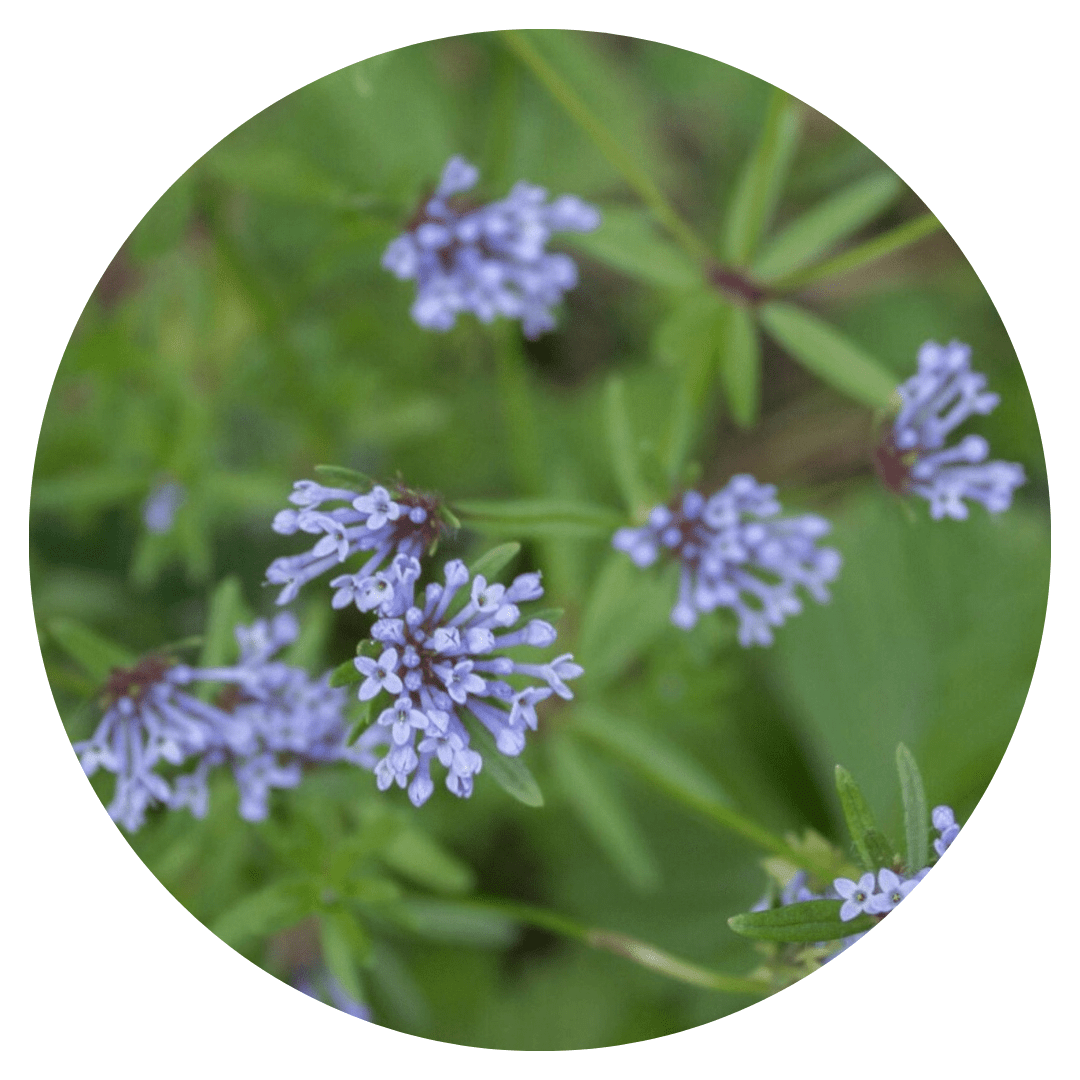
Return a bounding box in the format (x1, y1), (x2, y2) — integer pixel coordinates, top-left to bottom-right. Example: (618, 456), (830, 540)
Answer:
(468, 899), (770, 997)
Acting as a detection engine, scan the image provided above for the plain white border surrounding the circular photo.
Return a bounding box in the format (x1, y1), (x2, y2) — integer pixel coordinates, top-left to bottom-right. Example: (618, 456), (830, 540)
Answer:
(0, 0), (1080, 1078)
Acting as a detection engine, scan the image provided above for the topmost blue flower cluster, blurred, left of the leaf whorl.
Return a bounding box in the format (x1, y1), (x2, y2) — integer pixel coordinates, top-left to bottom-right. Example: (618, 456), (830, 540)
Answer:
(382, 157), (600, 338)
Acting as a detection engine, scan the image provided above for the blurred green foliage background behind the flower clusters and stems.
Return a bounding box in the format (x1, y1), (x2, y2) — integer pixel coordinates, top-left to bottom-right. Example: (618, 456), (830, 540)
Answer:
(30, 31), (1050, 1050)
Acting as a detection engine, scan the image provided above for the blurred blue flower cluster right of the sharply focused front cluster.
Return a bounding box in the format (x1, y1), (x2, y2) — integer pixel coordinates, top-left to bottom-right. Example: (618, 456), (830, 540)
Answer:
(611, 475), (840, 646)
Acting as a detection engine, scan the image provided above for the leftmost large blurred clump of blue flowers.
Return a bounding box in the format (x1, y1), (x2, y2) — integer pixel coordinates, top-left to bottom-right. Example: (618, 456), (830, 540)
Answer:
(75, 612), (350, 832)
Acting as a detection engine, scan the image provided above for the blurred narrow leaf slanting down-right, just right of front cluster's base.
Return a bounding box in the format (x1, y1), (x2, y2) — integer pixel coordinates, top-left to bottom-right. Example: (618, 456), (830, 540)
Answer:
(573, 705), (729, 808)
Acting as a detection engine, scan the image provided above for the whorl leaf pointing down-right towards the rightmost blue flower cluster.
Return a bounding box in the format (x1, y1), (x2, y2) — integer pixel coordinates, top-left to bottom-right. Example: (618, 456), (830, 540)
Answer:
(758, 300), (896, 408)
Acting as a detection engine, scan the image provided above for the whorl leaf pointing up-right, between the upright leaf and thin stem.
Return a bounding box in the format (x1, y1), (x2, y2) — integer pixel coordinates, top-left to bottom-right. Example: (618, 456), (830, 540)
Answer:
(754, 172), (903, 282)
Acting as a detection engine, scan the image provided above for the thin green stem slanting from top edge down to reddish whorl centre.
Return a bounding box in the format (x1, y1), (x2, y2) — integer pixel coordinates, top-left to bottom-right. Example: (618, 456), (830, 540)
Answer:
(500, 30), (711, 262)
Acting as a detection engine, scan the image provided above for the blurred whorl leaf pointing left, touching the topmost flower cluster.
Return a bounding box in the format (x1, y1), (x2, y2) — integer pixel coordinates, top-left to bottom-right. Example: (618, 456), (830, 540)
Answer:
(559, 206), (702, 289)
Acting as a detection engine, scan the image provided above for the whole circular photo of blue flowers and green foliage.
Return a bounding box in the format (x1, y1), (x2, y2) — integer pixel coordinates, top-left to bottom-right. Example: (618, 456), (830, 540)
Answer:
(30, 30), (1050, 1050)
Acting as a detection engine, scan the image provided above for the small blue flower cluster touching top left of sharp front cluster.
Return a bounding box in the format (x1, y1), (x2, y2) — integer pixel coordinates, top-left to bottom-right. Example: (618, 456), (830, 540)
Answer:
(267, 480), (443, 611)
